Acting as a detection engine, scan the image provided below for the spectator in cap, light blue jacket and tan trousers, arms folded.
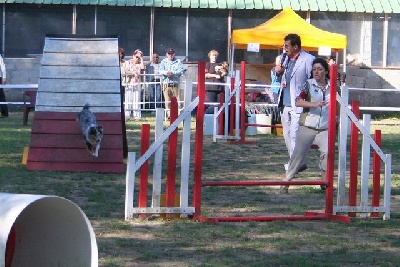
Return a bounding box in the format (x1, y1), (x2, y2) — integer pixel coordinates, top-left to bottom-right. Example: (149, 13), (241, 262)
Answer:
(160, 48), (183, 120)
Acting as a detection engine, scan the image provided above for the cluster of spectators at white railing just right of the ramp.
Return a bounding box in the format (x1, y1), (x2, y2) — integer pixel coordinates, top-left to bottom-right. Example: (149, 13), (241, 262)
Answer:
(119, 48), (184, 120)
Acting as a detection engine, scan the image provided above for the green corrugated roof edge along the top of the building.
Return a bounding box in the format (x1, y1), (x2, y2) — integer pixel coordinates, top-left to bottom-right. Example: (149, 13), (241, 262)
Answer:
(0, 0), (400, 13)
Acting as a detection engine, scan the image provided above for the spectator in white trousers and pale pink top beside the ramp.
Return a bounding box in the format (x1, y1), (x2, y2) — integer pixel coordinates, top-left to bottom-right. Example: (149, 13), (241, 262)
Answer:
(125, 49), (145, 120)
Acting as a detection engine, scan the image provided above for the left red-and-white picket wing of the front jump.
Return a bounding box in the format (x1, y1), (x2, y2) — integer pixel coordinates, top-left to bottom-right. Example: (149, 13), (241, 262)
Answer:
(125, 62), (205, 220)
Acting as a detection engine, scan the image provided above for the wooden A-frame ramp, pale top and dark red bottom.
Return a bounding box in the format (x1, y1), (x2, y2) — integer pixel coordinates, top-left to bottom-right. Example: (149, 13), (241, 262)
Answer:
(26, 36), (126, 173)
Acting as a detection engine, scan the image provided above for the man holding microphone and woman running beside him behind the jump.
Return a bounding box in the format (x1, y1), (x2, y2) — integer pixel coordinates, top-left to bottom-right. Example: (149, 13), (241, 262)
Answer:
(272, 33), (338, 193)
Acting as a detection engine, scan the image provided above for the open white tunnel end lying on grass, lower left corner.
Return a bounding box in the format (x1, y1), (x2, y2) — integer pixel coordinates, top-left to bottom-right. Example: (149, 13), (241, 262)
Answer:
(0, 193), (98, 267)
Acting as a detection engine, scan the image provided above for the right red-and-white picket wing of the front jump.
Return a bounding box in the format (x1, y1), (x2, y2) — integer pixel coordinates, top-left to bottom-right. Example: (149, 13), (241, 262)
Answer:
(334, 86), (392, 220)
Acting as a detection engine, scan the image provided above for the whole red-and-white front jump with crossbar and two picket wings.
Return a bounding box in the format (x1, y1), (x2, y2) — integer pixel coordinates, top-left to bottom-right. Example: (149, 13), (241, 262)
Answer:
(125, 63), (391, 223)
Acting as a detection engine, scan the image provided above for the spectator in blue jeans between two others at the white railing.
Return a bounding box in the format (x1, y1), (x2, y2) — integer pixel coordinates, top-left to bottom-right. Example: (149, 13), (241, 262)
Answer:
(146, 54), (162, 109)
